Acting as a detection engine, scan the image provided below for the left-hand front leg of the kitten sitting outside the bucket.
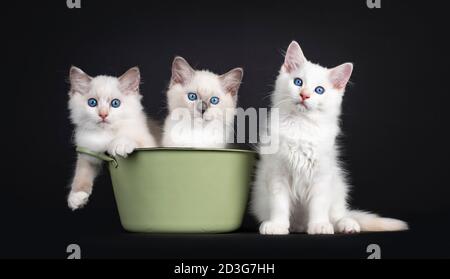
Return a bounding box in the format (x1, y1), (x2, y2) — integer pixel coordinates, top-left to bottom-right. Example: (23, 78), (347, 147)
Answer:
(259, 178), (291, 235)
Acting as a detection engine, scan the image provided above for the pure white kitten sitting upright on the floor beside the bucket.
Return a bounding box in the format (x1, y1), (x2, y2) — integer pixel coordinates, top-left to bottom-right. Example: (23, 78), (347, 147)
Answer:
(251, 41), (408, 234)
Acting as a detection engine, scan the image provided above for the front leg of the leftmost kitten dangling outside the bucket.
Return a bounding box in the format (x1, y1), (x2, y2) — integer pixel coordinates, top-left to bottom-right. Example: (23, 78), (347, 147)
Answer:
(67, 154), (101, 210)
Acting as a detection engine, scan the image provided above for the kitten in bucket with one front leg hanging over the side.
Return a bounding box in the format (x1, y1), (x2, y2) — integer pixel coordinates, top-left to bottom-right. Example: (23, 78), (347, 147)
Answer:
(68, 67), (156, 210)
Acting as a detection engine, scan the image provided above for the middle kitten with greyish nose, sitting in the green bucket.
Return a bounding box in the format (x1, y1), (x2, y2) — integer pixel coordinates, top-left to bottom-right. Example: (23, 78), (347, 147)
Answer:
(162, 57), (243, 148)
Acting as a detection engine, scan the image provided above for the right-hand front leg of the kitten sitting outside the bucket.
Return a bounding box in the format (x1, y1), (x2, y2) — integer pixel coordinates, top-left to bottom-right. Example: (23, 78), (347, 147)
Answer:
(307, 180), (334, 234)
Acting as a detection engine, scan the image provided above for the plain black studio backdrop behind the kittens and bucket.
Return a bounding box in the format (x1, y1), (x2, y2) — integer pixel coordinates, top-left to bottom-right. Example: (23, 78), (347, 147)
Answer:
(4, 0), (450, 258)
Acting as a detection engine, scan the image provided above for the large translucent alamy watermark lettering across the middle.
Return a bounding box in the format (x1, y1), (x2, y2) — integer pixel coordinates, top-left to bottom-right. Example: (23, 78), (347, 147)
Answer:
(168, 107), (279, 154)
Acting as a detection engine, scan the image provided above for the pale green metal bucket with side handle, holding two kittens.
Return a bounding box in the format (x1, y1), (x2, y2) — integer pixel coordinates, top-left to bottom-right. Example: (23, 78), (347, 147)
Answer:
(77, 147), (255, 233)
